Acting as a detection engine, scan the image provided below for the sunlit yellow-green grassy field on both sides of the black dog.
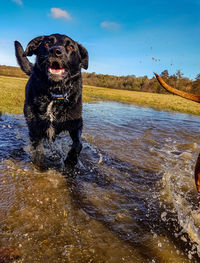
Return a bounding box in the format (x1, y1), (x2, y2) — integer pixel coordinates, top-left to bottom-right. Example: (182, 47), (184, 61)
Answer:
(0, 76), (200, 116)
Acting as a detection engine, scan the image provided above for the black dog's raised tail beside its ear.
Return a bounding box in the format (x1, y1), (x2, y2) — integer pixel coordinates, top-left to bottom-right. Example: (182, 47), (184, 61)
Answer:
(15, 41), (33, 76)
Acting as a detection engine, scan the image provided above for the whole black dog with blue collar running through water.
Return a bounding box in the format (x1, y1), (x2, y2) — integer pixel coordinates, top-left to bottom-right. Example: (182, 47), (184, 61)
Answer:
(15, 34), (88, 166)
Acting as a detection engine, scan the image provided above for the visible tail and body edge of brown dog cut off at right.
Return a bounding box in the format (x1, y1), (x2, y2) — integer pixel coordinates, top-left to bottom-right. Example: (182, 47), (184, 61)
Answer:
(154, 73), (200, 193)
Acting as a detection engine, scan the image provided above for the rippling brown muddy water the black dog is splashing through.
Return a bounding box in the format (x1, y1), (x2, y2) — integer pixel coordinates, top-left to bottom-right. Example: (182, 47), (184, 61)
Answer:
(0, 102), (200, 263)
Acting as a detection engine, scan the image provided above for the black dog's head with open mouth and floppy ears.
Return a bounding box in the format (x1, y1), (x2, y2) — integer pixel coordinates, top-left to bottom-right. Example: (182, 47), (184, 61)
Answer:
(24, 34), (88, 82)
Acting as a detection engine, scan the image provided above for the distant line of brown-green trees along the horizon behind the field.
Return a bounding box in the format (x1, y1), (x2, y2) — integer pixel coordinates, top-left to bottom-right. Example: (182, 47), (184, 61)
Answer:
(0, 66), (200, 95)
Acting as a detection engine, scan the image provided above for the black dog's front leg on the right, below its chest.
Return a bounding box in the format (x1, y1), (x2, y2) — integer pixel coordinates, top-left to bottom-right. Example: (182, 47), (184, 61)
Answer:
(65, 128), (82, 167)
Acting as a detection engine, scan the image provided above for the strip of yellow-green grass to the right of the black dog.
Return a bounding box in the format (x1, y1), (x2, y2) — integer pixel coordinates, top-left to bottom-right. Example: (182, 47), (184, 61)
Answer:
(83, 86), (200, 116)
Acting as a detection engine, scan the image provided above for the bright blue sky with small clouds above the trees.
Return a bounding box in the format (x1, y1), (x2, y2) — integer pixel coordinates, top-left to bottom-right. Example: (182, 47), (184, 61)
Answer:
(0, 0), (200, 79)
